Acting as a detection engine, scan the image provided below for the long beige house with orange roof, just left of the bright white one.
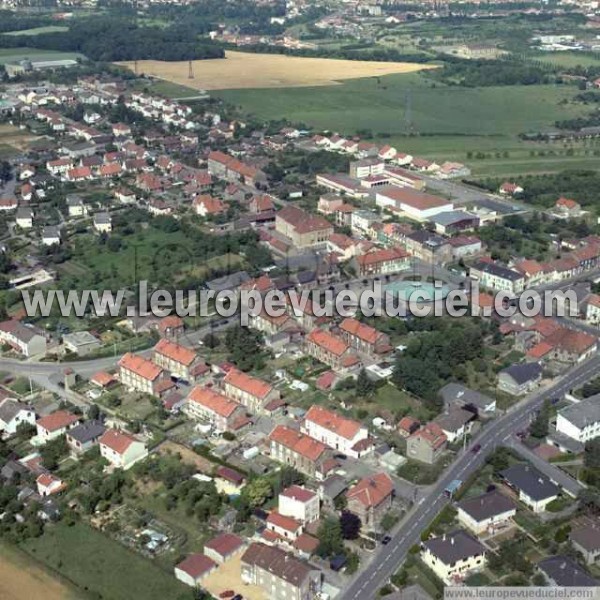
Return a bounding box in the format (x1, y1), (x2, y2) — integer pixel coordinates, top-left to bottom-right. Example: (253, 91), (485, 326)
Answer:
(269, 425), (330, 477)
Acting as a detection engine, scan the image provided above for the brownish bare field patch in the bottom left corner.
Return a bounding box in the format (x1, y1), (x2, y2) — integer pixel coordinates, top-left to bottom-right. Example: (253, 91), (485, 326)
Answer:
(0, 544), (85, 600)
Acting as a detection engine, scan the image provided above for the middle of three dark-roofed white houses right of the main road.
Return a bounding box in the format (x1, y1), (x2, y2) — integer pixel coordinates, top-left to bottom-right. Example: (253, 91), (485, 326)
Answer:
(456, 490), (517, 536)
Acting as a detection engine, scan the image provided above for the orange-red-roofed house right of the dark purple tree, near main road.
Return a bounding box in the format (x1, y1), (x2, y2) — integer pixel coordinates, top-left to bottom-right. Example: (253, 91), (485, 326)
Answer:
(346, 473), (394, 530)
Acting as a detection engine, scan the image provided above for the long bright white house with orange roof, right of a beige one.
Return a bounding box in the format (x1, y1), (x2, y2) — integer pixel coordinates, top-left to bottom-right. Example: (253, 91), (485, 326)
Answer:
(302, 404), (373, 458)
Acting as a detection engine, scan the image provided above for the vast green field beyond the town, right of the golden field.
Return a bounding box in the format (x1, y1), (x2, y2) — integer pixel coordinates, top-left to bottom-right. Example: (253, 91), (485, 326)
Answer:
(211, 74), (600, 176)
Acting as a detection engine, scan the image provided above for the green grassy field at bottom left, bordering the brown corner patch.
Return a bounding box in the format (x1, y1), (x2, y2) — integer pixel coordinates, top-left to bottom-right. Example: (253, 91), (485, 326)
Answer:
(21, 523), (188, 600)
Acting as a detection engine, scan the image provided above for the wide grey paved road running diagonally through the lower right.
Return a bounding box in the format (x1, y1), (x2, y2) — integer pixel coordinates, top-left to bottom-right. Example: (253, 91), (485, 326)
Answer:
(341, 355), (600, 600)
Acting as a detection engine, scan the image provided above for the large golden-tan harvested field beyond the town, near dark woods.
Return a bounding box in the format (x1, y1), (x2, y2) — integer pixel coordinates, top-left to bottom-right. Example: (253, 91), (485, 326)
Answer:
(118, 51), (435, 90)
